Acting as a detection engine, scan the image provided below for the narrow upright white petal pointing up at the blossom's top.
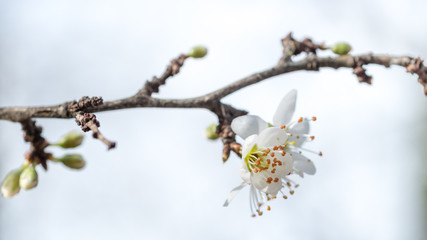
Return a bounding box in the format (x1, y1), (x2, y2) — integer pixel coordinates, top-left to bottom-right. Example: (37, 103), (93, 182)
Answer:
(273, 89), (297, 127)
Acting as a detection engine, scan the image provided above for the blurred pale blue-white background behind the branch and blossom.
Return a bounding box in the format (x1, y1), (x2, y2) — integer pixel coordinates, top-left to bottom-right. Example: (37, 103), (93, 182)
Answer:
(0, 0), (427, 240)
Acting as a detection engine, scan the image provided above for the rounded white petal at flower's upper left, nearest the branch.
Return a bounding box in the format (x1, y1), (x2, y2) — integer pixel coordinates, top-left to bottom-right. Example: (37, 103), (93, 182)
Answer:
(231, 115), (268, 139)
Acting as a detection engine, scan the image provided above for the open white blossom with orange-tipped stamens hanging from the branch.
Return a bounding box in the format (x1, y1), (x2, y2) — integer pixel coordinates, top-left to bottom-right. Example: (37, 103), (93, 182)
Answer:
(224, 90), (321, 216)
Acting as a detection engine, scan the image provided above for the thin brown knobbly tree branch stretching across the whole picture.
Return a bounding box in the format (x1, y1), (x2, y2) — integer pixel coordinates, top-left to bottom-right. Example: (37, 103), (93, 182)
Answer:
(0, 34), (427, 158)
